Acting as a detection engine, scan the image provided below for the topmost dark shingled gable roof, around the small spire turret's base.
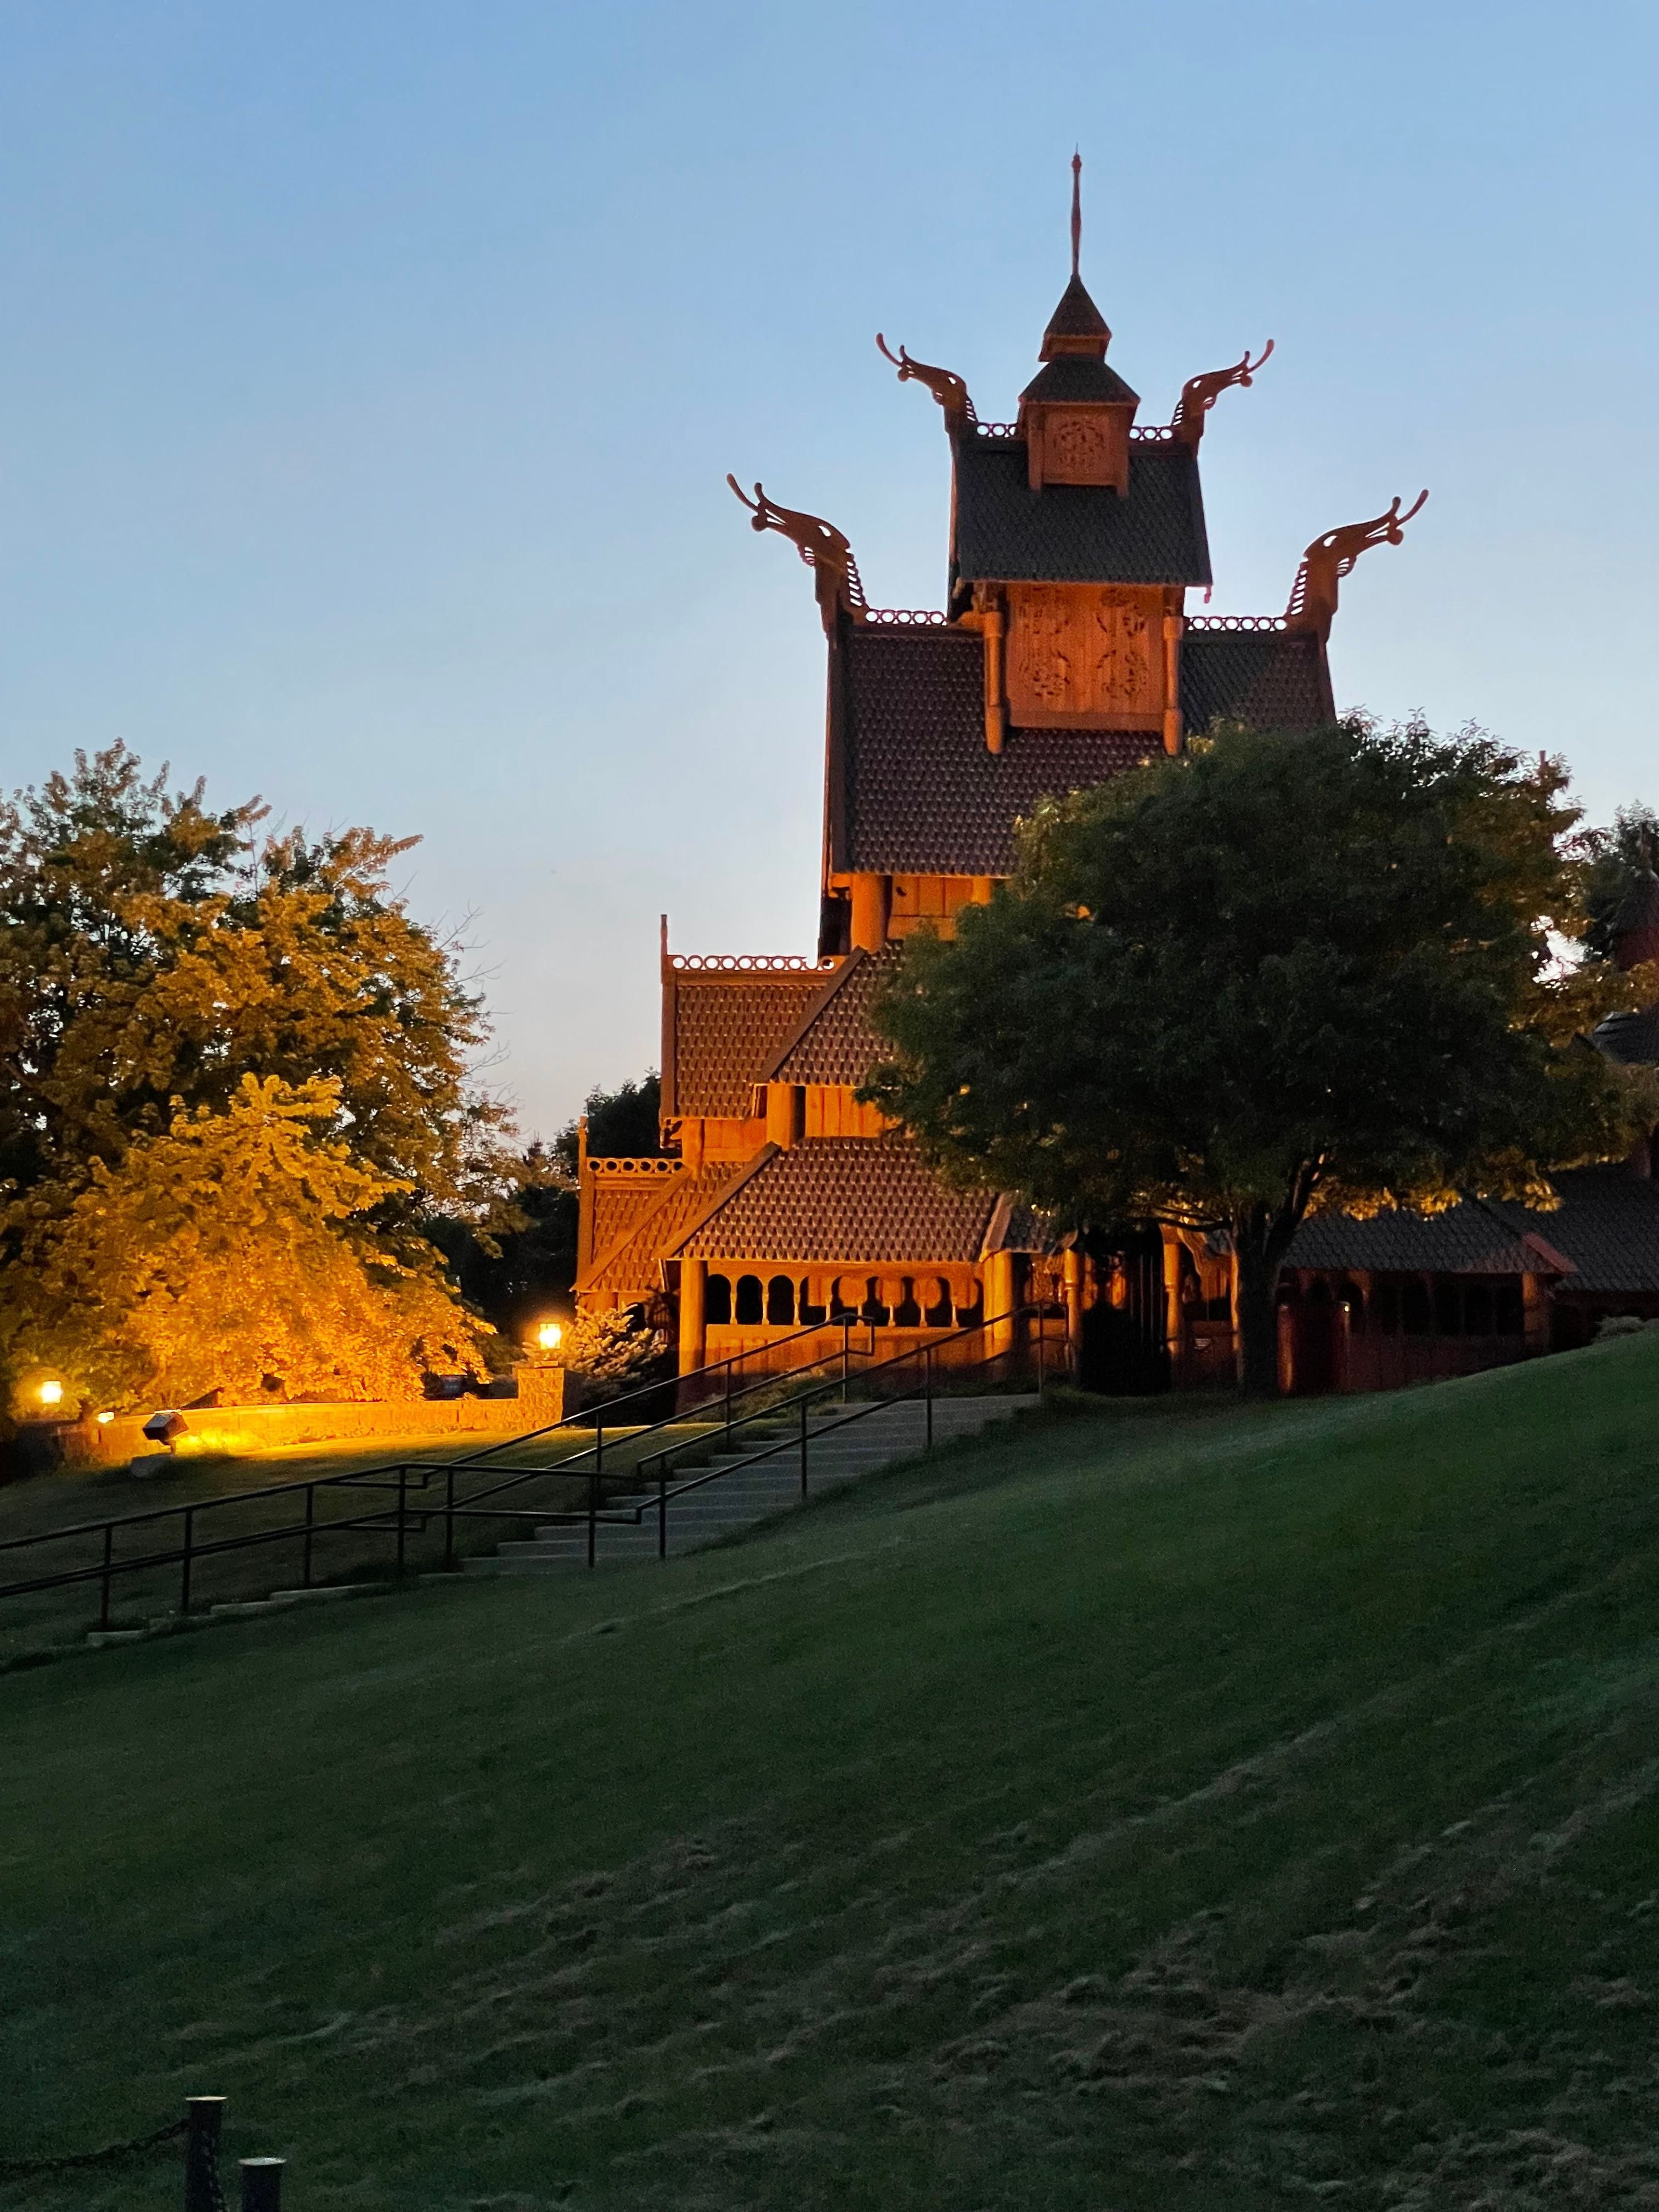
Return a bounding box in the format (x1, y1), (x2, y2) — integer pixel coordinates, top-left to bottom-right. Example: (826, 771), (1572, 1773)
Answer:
(951, 431), (1210, 586)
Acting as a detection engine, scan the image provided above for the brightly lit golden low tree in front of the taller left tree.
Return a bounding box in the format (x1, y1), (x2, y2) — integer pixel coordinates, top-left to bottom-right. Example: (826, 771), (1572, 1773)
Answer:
(7, 1075), (487, 1404)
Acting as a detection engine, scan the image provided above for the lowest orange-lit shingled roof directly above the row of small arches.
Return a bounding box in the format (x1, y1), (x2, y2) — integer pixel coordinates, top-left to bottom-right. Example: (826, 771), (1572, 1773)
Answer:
(677, 1137), (997, 1267)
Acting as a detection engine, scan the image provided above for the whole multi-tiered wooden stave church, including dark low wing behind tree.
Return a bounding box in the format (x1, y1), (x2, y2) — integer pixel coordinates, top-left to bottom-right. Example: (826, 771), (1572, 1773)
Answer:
(575, 161), (1659, 1389)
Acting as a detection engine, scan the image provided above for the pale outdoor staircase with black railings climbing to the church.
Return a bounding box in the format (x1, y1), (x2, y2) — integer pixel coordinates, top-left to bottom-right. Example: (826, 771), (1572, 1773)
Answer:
(465, 1393), (1040, 1575)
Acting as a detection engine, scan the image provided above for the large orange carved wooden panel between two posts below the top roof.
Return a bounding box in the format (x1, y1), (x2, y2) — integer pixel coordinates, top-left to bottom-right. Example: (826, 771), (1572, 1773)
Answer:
(1007, 584), (1164, 730)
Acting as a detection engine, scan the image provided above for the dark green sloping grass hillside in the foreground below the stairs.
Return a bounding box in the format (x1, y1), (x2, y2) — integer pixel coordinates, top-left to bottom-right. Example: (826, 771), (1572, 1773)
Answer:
(0, 1334), (1659, 2212)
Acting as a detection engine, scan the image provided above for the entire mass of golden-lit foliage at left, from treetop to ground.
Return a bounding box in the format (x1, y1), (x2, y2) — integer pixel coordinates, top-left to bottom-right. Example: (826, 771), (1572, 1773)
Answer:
(0, 746), (511, 1402)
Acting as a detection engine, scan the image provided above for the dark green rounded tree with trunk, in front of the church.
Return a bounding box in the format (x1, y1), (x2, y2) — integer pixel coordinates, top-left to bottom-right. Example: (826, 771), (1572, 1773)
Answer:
(862, 721), (1652, 1393)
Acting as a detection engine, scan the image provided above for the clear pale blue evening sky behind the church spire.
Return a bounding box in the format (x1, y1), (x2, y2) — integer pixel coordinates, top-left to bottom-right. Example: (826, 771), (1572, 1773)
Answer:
(0, 0), (1659, 1130)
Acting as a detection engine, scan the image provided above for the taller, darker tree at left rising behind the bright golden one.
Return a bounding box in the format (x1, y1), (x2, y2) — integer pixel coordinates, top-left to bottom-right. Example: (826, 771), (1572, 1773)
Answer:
(0, 746), (506, 1228)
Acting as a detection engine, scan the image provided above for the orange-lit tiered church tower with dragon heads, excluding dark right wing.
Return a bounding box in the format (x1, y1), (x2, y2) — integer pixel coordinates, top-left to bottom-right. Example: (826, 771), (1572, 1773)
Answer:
(577, 159), (1423, 1372)
